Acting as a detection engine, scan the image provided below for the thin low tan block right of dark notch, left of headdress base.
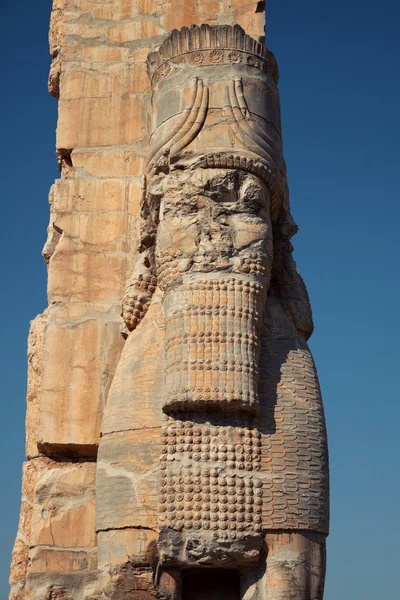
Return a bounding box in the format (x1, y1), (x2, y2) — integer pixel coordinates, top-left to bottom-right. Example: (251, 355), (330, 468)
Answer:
(72, 149), (144, 178)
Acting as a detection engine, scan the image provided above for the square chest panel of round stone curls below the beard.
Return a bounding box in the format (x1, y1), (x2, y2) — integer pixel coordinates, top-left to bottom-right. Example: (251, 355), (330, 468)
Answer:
(160, 415), (263, 539)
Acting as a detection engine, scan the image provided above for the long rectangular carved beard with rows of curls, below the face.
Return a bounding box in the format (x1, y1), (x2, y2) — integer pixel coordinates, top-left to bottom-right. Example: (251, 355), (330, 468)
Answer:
(164, 277), (264, 412)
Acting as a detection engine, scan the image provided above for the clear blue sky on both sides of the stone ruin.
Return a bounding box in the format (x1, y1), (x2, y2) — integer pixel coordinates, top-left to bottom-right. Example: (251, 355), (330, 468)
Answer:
(0, 0), (400, 600)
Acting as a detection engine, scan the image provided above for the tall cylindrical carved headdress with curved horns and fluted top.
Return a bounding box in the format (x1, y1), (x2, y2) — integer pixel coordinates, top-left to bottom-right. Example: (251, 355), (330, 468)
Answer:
(147, 25), (287, 220)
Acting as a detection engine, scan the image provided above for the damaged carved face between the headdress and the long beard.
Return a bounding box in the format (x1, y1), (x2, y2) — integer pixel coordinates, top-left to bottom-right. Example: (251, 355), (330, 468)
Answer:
(156, 169), (273, 285)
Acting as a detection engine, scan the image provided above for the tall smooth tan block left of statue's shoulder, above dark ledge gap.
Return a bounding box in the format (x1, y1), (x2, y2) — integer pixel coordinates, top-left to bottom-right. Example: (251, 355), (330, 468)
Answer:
(38, 319), (121, 456)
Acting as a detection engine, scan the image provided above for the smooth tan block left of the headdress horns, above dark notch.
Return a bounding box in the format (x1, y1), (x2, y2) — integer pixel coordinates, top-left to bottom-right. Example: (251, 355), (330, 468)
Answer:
(57, 95), (145, 148)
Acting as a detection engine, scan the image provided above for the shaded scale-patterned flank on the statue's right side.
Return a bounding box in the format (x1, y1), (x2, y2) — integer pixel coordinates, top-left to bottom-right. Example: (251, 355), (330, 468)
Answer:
(260, 322), (329, 533)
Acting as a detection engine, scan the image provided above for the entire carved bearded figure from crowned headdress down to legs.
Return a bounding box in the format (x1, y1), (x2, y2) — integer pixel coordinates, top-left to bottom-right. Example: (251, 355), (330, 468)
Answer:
(93, 26), (329, 600)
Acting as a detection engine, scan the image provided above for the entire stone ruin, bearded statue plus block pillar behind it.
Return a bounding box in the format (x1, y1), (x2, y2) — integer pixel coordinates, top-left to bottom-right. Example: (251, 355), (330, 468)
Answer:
(11, 0), (329, 600)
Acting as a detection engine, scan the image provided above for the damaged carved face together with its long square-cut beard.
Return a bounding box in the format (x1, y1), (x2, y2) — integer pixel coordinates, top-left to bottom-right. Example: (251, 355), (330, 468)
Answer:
(155, 169), (273, 413)
